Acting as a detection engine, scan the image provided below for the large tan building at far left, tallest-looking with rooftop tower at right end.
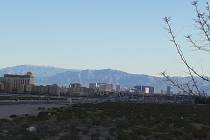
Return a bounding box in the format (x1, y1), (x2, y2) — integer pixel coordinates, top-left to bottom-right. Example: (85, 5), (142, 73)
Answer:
(0, 72), (34, 93)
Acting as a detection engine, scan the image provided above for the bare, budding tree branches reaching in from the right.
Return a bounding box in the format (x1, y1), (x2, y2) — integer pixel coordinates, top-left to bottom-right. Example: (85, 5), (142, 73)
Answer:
(162, 1), (210, 96)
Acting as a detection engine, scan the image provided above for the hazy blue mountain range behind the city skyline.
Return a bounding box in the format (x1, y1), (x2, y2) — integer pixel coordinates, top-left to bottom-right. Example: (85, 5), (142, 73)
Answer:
(0, 65), (210, 92)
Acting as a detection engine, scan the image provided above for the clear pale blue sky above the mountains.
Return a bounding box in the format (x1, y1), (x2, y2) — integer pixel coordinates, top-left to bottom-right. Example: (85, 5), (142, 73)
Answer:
(0, 0), (210, 75)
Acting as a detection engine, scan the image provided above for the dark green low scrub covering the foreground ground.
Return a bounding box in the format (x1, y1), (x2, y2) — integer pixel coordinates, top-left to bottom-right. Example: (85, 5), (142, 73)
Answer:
(0, 103), (210, 140)
